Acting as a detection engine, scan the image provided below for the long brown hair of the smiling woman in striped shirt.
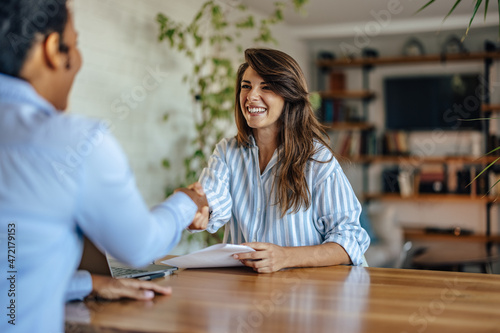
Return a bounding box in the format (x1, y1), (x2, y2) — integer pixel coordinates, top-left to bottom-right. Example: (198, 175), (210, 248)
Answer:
(235, 49), (334, 217)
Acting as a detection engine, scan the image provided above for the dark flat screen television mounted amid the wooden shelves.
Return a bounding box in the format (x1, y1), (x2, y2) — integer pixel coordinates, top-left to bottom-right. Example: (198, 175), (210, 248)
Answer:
(384, 74), (481, 131)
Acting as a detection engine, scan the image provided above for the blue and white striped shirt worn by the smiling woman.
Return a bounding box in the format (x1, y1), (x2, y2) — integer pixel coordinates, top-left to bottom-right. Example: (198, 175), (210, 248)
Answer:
(200, 136), (370, 265)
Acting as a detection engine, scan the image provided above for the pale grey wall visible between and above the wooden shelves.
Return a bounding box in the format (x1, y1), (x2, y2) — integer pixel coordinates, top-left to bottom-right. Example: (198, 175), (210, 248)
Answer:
(308, 27), (500, 232)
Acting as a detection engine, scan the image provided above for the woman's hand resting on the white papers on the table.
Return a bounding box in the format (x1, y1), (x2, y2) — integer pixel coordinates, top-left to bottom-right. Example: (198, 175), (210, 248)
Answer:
(233, 242), (288, 273)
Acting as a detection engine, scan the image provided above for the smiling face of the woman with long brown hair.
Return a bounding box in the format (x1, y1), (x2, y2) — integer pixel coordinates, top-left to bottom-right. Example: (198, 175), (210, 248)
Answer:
(240, 67), (285, 133)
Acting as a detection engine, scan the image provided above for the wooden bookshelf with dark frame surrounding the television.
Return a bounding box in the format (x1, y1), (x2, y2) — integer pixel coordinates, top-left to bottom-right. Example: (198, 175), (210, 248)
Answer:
(316, 51), (500, 235)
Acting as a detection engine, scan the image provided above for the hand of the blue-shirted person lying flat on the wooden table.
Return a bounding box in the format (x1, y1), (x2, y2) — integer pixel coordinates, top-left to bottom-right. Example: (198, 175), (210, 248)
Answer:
(90, 274), (172, 300)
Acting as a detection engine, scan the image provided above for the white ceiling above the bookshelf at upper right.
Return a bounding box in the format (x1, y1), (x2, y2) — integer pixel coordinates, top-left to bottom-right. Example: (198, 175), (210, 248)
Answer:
(241, 0), (498, 38)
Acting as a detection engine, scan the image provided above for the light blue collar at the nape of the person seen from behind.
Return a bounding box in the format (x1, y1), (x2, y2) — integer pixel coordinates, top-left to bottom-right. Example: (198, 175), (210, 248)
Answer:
(0, 73), (57, 115)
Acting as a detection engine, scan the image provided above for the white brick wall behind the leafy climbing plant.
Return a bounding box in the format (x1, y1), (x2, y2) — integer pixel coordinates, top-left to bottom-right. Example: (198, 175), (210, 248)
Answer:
(70, 0), (309, 206)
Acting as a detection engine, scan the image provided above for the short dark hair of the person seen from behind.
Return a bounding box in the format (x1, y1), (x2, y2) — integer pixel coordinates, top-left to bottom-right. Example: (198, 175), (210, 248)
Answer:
(0, 0), (68, 77)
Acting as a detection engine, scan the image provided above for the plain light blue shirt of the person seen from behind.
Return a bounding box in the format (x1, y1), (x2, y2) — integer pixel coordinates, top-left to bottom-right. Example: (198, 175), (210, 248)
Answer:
(0, 74), (197, 333)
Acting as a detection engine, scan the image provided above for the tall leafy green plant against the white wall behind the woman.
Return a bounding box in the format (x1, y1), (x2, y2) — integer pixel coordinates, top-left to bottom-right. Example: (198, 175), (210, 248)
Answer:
(156, 0), (309, 245)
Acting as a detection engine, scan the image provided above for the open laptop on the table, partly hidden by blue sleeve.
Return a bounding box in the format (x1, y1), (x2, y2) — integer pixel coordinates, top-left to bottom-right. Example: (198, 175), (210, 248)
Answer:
(78, 237), (177, 279)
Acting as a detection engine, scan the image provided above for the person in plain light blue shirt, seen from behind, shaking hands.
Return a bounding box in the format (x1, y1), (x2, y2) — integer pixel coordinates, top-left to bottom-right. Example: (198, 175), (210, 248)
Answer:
(0, 0), (208, 333)
